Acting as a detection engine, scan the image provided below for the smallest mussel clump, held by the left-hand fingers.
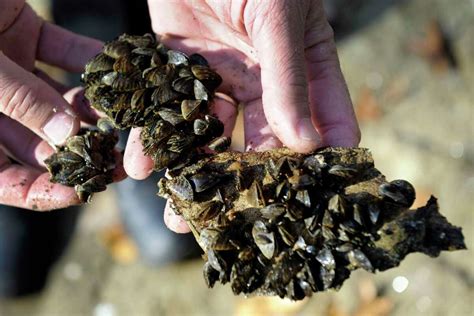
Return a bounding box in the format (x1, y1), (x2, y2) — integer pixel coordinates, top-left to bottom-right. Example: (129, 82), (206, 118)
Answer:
(45, 120), (118, 202)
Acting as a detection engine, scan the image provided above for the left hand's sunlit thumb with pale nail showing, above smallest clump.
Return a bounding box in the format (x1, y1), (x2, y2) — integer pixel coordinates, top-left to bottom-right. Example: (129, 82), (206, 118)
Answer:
(0, 52), (79, 145)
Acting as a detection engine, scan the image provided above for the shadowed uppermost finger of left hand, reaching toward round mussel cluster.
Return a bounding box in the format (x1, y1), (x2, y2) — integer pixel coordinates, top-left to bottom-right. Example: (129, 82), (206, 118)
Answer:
(36, 22), (103, 72)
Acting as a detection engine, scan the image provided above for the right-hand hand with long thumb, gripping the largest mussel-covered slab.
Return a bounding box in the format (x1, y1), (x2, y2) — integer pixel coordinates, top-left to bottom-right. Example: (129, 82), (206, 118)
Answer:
(125, 0), (360, 231)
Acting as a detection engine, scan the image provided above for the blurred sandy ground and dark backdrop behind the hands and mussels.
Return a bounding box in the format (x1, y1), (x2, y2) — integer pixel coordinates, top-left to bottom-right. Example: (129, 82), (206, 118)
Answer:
(0, 0), (474, 316)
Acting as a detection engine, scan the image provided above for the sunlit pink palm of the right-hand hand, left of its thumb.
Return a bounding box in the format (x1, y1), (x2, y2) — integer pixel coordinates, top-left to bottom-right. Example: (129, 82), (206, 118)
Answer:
(150, 1), (272, 149)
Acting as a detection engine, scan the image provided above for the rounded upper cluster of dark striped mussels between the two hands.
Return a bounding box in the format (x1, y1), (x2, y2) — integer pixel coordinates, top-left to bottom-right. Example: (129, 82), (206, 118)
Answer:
(82, 34), (230, 170)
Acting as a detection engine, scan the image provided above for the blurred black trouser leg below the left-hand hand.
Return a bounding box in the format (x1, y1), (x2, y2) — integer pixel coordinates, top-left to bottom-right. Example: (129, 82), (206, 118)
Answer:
(0, 205), (79, 297)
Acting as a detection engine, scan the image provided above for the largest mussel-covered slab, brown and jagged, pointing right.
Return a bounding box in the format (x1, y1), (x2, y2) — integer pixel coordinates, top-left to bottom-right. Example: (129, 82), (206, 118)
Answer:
(159, 148), (465, 300)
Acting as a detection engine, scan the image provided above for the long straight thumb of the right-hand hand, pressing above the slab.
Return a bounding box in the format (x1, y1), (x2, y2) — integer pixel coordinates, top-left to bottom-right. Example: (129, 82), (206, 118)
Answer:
(250, 1), (321, 152)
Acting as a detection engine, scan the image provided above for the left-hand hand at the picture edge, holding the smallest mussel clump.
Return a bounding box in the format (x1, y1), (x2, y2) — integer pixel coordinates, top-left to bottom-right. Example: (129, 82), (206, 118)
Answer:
(0, 0), (122, 210)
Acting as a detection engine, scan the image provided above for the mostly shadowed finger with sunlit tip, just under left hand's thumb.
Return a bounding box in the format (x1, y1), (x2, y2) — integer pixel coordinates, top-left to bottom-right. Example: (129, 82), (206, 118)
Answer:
(0, 115), (54, 169)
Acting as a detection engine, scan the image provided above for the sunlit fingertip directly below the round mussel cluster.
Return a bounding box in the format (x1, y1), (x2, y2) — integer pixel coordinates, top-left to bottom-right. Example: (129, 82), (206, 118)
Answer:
(123, 128), (153, 180)
